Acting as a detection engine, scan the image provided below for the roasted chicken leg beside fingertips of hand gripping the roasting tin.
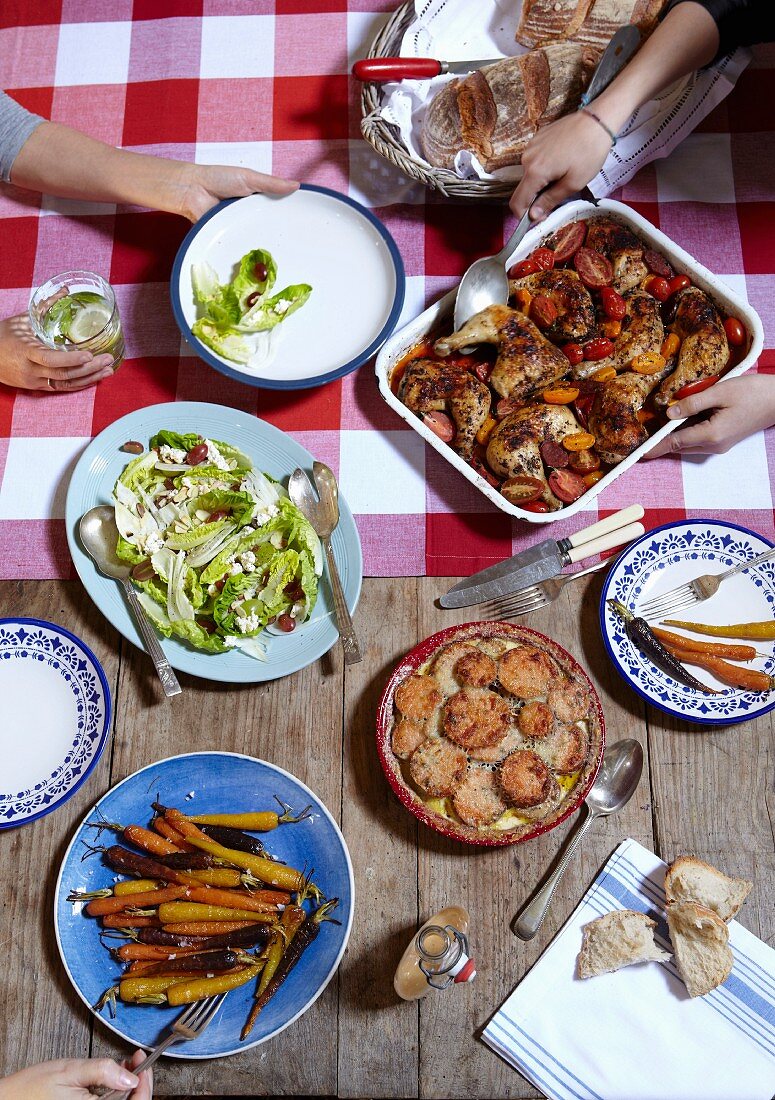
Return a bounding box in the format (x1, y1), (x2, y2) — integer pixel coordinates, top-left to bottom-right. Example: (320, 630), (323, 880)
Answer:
(589, 371), (665, 465)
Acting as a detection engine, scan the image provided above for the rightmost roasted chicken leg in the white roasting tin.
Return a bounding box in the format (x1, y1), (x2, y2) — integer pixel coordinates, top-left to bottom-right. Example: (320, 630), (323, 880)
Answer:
(654, 286), (729, 407)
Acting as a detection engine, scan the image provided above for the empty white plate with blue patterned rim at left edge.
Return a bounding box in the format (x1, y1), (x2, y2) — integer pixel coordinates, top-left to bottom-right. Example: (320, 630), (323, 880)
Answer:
(0, 618), (111, 828)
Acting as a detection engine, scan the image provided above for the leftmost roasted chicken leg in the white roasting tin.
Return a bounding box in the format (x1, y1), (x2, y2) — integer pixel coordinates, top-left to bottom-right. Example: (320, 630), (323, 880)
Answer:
(399, 359), (490, 459)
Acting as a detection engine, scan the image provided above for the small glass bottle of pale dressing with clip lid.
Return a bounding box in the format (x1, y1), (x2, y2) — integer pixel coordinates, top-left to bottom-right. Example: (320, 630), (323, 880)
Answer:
(392, 905), (476, 1001)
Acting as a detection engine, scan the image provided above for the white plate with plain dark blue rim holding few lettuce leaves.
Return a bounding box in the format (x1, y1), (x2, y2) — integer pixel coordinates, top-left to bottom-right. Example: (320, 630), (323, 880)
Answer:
(169, 184), (406, 389)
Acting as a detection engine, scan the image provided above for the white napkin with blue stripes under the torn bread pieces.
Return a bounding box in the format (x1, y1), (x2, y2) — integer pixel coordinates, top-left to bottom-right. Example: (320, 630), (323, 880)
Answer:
(483, 840), (775, 1100)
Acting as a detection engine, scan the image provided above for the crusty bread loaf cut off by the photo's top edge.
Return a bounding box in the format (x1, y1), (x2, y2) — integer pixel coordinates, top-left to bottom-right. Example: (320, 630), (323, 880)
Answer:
(517, 0), (666, 50)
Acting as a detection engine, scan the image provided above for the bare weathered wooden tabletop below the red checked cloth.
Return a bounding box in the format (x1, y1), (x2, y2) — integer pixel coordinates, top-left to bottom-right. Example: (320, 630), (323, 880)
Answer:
(0, 578), (775, 1098)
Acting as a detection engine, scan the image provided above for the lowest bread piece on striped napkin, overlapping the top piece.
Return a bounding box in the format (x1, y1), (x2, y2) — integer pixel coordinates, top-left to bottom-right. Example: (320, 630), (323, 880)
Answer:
(667, 901), (733, 997)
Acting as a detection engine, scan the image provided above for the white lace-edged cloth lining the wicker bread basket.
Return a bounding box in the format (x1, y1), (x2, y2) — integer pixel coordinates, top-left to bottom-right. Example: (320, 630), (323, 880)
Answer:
(373, 0), (751, 198)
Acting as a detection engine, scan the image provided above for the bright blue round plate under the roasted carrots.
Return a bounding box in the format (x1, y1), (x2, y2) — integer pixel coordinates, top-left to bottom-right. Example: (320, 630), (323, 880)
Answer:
(54, 752), (354, 1058)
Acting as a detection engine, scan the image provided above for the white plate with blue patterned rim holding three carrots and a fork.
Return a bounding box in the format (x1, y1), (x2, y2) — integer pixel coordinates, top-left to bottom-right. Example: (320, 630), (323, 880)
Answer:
(600, 518), (775, 726)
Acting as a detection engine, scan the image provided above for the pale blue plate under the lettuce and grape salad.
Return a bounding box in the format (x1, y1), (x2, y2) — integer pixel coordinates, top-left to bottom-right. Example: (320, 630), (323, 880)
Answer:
(65, 402), (363, 684)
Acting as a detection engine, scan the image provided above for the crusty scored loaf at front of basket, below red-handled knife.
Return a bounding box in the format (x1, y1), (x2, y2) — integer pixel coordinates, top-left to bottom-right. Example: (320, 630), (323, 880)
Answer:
(421, 42), (597, 172)
